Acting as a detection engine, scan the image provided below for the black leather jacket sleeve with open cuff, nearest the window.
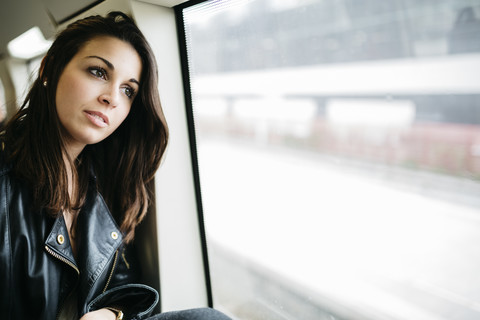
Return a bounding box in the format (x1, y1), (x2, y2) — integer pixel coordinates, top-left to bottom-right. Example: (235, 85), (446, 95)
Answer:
(87, 242), (159, 319)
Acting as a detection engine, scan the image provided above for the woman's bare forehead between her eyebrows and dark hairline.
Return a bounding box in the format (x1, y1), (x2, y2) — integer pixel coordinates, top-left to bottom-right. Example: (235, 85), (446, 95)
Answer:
(74, 36), (142, 79)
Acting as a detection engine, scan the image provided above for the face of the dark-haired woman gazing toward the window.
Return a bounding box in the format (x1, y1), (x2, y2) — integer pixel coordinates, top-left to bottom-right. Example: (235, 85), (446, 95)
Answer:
(55, 36), (142, 157)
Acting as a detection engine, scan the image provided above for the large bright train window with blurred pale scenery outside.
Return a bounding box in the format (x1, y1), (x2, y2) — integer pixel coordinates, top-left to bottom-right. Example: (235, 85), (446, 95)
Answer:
(182, 0), (480, 320)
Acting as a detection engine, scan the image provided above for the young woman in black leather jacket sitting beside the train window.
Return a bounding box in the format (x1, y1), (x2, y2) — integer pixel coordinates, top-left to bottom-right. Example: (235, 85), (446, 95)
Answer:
(0, 12), (231, 320)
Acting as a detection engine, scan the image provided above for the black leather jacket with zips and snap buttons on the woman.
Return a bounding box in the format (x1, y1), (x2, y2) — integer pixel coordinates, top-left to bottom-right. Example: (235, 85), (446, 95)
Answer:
(0, 161), (158, 320)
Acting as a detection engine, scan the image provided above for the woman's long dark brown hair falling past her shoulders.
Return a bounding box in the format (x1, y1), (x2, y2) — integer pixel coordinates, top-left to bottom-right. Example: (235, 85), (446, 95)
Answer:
(2, 12), (168, 242)
